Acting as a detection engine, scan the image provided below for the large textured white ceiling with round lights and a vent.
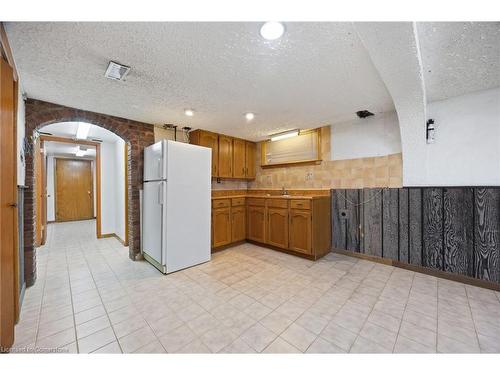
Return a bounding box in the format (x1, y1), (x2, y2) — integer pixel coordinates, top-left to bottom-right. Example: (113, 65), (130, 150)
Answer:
(6, 23), (394, 140)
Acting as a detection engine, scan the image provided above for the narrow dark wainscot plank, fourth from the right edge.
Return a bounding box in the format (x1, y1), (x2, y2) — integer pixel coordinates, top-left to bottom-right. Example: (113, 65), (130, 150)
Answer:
(408, 188), (422, 266)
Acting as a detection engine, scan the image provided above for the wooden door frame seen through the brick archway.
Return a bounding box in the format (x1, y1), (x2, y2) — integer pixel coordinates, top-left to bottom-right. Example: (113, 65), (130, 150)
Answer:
(37, 134), (102, 238)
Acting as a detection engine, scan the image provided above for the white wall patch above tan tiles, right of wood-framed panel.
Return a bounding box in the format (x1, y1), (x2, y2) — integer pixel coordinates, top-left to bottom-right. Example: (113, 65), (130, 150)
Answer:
(330, 112), (401, 160)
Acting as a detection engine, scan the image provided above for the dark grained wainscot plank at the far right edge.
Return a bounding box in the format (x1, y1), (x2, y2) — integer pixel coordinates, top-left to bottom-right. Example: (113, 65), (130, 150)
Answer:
(474, 188), (500, 282)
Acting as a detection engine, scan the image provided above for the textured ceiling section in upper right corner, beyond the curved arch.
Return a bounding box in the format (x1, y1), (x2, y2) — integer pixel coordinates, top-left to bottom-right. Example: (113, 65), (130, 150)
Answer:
(417, 22), (500, 102)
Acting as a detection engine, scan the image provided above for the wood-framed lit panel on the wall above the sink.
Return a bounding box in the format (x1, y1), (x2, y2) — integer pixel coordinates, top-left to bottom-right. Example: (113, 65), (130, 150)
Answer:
(261, 128), (321, 168)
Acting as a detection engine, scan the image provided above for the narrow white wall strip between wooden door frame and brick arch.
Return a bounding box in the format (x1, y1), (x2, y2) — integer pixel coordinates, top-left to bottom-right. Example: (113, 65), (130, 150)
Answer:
(114, 138), (127, 241)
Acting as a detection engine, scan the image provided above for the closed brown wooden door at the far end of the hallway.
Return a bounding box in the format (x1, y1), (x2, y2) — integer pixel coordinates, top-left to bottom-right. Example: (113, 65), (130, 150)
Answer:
(56, 159), (94, 221)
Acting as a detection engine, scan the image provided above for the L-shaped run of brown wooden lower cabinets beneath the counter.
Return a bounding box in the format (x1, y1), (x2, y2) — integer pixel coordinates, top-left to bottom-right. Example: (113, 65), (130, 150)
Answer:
(212, 196), (331, 259)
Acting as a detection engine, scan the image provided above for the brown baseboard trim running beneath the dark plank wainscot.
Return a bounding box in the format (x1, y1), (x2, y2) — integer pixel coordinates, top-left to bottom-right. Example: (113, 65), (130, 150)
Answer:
(332, 249), (500, 291)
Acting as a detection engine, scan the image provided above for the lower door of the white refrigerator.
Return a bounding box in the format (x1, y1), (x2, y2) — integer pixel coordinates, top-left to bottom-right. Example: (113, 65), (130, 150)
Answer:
(142, 181), (166, 266)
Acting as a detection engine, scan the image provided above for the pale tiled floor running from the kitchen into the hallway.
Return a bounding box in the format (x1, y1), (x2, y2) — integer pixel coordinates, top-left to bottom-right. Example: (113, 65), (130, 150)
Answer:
(10, 221), (500, 353)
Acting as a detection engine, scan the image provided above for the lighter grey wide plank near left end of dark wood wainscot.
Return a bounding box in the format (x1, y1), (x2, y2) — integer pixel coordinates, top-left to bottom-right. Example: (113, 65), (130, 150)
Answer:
(363, 189), (383, 257)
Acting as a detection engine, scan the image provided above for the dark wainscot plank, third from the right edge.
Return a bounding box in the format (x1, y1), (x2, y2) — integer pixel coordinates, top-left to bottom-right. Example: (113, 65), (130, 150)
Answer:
(422, 188), (443, 270)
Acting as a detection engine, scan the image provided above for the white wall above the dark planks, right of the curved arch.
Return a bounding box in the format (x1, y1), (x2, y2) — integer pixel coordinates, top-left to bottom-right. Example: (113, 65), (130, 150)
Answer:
(424, 88), (500, 186)
